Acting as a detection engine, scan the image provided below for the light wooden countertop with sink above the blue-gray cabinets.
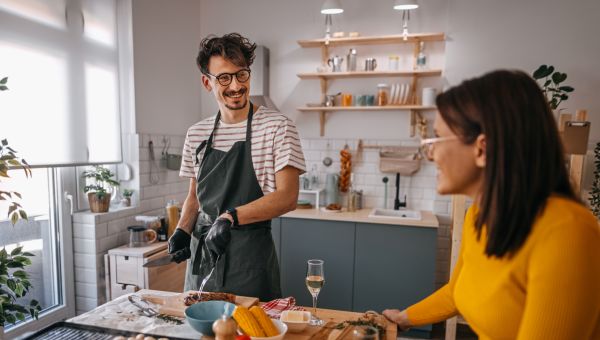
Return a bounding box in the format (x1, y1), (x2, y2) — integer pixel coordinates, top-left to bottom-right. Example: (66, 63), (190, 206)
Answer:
(281, 209), (440, 228)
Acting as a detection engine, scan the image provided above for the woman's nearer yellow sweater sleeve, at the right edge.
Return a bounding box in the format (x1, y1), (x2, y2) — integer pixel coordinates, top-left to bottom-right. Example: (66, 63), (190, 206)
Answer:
(518, 215), (600, 340)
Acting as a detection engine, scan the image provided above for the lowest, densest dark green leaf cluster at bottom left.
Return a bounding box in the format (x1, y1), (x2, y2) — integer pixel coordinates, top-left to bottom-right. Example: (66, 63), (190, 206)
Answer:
(0, 247), (42, 326)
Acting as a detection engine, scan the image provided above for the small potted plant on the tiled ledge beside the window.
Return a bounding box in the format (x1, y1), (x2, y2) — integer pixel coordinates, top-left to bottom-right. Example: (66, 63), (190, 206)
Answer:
(82, 165), (119, 213)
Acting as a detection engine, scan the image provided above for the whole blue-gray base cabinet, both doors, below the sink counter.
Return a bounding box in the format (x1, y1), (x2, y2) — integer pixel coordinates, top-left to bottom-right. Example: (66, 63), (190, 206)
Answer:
(273, 217), (438, 318)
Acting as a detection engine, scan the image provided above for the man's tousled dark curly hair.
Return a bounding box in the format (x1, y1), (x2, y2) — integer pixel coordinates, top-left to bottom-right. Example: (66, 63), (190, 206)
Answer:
(196, 33), (256, 74)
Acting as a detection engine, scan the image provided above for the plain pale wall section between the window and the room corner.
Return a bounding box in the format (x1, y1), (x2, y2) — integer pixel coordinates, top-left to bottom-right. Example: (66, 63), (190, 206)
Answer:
(133, 0), (201, 135)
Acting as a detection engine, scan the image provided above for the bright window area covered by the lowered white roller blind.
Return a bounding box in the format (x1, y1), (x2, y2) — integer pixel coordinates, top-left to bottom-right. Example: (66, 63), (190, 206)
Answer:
(0, 0), (121, 166)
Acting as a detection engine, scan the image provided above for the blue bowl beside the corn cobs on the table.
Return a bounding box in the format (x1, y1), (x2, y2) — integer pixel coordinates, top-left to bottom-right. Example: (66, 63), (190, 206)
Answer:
(185, 301), (235, 336)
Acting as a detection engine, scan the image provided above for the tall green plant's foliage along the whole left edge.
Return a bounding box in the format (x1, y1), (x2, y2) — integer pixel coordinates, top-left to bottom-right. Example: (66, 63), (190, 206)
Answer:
(0, 77), (41, 332)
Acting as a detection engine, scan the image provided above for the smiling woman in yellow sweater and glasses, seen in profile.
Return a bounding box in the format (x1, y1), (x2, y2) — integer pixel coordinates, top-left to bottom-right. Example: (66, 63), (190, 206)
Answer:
(383, 71), (600, 340)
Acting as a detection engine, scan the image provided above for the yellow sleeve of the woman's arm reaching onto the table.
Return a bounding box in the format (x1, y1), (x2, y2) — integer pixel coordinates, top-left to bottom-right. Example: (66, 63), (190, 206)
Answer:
(406, 206), (474, 326)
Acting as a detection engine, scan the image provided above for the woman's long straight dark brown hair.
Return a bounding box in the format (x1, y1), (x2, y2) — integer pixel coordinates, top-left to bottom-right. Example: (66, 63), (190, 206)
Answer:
(436, 70), (577, 258)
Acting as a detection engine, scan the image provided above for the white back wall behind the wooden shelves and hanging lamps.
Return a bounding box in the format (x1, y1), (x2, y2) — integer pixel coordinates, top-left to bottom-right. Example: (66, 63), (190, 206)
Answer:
(195, 0), (600, 139)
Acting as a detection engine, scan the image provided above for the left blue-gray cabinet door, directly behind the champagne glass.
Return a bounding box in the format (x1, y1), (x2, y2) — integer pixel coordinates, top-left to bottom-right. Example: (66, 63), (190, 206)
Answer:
(281, 218), (355, 310)
